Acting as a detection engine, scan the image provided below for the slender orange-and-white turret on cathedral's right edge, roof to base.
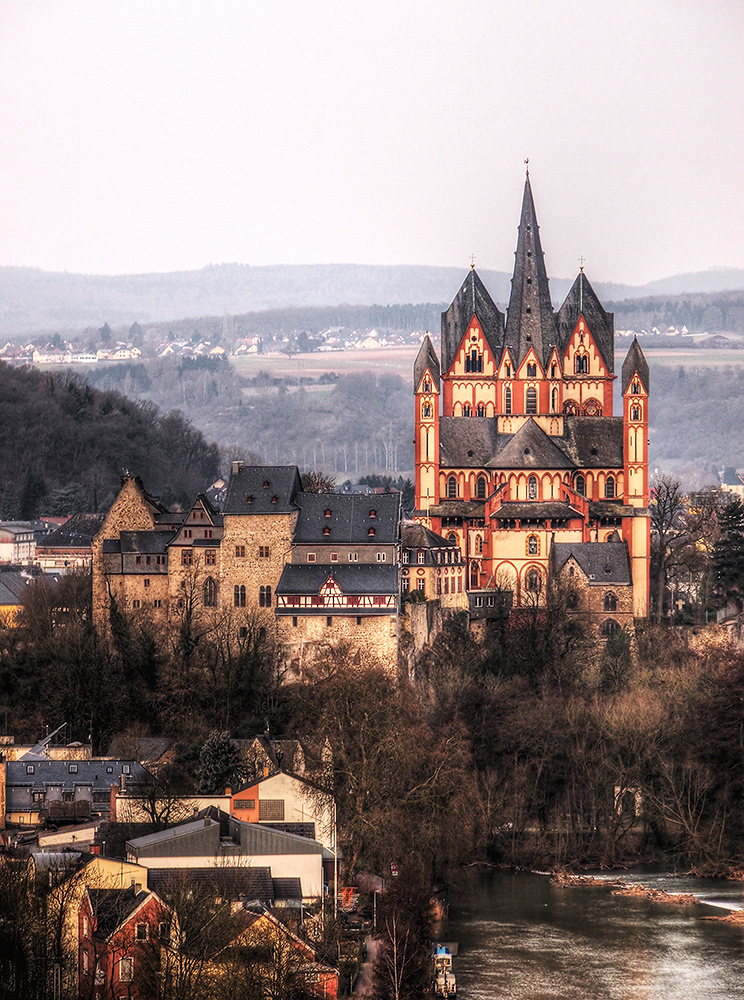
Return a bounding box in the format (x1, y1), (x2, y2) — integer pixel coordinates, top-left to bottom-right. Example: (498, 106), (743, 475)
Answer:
(622, 337), (651, 618)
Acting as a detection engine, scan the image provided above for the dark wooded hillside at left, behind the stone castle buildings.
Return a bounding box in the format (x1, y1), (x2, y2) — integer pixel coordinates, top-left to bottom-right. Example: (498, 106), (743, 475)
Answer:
(0, 363), (219, 520)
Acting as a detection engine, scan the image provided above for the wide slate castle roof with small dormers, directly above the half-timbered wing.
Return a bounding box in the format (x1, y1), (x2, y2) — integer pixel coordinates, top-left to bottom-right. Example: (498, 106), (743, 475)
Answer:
(294, 493), (401, 545)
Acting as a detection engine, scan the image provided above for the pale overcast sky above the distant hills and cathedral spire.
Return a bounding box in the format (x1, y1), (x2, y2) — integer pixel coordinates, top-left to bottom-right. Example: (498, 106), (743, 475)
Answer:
(0, 0), (744, 283)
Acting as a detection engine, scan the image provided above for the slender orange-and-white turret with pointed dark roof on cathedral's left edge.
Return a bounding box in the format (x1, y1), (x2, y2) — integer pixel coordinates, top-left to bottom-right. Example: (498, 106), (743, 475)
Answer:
(413, 334), (440, 512)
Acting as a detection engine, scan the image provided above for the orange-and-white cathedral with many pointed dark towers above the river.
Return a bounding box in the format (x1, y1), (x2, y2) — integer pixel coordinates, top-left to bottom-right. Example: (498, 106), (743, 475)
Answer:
(414, 172), (650, 635)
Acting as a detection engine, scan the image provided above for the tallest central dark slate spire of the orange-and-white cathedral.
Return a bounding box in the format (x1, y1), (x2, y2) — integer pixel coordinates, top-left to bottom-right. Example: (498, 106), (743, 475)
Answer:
(505, 169), (558, 365)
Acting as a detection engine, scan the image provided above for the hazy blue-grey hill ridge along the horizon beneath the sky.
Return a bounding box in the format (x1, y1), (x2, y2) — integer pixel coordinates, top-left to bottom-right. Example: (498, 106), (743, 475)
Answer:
(0, 264), (744, 339)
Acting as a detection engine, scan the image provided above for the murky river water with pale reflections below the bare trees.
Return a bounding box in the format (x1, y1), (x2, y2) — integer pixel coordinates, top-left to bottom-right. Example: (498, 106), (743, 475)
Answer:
(443, 869), (744, 1000)
